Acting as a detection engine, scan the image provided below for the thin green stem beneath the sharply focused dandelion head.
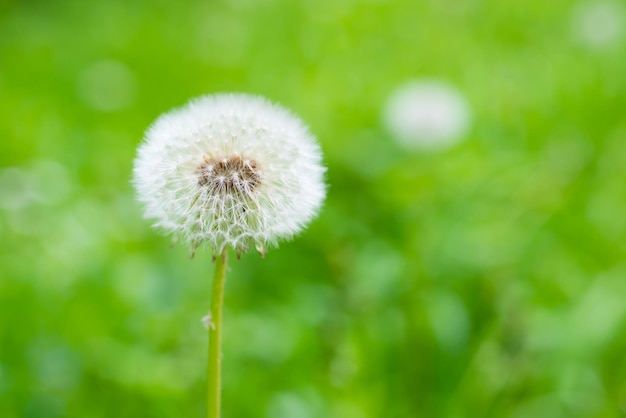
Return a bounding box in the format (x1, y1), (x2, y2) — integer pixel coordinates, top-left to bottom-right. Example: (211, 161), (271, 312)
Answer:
(207, 248), (228, 418)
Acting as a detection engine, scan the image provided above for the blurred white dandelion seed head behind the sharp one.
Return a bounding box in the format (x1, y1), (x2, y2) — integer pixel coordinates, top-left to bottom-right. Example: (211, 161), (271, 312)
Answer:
(383, 80), (470, 150)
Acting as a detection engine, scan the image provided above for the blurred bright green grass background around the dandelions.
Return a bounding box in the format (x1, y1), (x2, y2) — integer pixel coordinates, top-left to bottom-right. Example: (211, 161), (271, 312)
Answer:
(0, 0), (626, 418)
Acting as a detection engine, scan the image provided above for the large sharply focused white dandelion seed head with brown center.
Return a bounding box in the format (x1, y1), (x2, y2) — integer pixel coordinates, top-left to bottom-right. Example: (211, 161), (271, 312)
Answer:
(133, 94), (326, 254)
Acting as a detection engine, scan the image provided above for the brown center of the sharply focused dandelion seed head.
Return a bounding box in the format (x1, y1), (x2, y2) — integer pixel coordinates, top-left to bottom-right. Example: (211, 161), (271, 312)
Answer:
(198, 156), (261, 194)
